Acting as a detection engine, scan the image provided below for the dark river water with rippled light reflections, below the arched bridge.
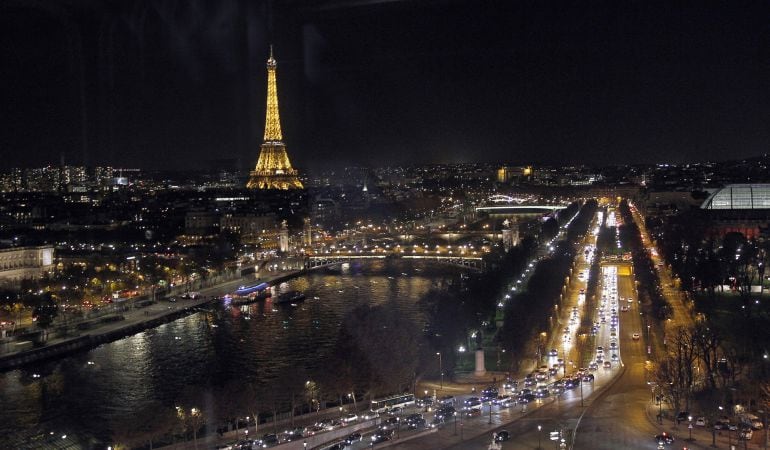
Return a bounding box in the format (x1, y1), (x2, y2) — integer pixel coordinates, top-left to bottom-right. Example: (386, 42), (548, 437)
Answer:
(0, 261), (458, 448)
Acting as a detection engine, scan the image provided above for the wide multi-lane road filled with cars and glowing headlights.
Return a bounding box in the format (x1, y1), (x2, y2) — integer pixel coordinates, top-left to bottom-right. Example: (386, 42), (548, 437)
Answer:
(338, 205), (710, 450)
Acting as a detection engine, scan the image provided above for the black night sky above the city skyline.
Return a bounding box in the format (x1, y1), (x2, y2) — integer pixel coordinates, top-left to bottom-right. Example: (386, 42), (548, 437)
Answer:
(0, 0), (770, 169)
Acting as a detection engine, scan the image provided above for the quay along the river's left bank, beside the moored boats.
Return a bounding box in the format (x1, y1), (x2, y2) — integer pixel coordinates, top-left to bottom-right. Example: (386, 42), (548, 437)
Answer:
(0, 270), (305, 371)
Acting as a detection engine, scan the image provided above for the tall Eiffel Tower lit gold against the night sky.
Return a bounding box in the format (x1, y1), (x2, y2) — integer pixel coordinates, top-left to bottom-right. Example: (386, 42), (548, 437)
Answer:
(246, 46), (302, 191)
